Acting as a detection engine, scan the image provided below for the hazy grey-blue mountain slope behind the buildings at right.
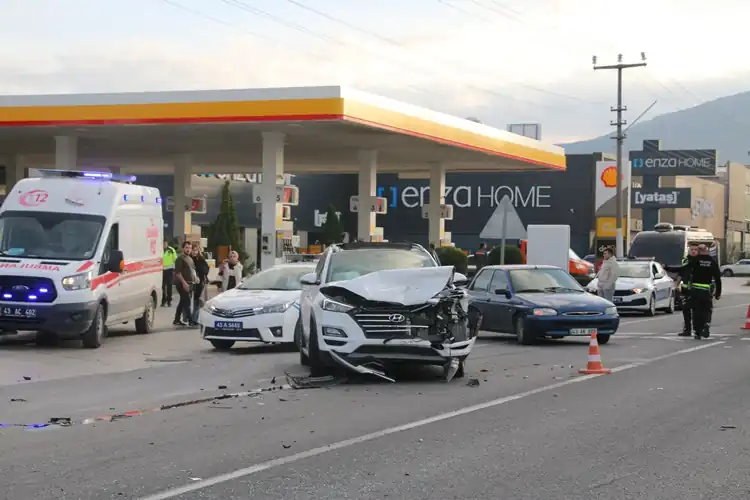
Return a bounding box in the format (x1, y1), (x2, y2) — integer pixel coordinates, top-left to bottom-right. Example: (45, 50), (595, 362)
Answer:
(561, 92), (750, 164)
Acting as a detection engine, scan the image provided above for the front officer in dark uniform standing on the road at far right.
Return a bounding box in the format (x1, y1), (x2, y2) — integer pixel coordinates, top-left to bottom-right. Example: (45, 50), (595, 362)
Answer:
(664, 245), (721, 339)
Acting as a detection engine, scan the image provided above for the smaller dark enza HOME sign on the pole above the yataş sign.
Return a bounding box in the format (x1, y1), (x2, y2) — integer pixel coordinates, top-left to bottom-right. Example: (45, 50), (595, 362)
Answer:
(630, 149), (716, 176)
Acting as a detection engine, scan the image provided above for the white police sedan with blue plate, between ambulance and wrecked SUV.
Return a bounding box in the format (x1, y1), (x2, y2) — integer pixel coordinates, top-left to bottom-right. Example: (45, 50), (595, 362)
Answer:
(198, 263), (315, 350)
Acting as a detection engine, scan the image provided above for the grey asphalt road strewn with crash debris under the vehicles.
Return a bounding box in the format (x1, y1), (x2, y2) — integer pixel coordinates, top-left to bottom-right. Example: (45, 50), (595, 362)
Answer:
(0, 295), (750, 500)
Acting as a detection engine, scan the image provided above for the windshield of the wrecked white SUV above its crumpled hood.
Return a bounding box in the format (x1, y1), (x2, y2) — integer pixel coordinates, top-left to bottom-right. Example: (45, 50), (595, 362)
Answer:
(326, 248), (437, 282)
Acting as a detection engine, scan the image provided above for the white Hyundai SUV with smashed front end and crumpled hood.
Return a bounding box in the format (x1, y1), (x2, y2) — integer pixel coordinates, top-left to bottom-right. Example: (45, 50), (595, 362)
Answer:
(295, 242), (478, 382)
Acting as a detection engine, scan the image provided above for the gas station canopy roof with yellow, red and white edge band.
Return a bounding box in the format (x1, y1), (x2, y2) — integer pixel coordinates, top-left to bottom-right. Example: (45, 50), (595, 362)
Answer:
(0, 86), (565, 173)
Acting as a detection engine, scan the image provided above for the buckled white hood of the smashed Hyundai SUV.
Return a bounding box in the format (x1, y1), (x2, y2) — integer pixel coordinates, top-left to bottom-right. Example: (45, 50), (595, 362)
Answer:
(320, 266), (453, 306)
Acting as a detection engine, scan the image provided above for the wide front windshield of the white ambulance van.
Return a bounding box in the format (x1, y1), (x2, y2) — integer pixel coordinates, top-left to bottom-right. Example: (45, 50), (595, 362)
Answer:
(0, 210), (105, 260)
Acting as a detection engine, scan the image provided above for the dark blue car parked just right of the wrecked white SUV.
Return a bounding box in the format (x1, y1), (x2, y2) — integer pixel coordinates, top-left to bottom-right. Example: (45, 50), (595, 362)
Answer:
(468, 266), (620, 345)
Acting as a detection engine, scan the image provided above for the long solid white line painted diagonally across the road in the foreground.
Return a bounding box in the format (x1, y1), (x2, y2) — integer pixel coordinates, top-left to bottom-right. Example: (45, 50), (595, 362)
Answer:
(140, 342), (724, 500)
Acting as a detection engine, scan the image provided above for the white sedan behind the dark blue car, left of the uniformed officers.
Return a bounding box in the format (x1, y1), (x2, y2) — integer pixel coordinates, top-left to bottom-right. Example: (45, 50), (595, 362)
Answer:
(586, 260), (675, 316)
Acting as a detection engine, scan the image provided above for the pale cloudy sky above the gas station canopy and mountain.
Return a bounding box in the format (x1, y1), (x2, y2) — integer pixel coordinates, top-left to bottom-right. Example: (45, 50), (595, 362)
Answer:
(0, 0), (750, 143)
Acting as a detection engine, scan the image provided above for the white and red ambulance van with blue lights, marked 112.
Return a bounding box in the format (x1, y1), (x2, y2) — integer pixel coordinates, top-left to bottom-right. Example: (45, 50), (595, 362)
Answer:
(0, 169), (164, 349)
